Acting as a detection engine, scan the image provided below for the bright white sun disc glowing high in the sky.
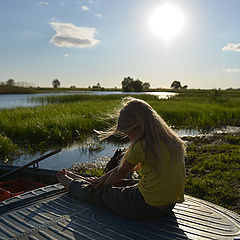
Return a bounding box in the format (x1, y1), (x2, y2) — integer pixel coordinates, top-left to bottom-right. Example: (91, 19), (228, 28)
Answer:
(150, 3), (185, 41)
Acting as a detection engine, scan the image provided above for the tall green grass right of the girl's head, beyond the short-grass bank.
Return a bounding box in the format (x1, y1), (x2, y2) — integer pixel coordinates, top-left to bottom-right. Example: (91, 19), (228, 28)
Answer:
(152, 90), (240, 130)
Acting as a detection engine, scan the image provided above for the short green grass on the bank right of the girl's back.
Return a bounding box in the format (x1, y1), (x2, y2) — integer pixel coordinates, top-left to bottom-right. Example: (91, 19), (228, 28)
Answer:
(185, 136), (240, 213)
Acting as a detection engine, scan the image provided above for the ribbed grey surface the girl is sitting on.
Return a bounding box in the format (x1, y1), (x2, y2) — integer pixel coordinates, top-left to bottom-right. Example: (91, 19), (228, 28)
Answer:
(0, 184), (240, 240)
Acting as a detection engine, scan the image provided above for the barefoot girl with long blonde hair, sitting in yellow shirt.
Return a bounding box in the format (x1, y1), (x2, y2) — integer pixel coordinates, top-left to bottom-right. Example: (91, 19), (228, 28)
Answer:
(57, 98), (185, 219)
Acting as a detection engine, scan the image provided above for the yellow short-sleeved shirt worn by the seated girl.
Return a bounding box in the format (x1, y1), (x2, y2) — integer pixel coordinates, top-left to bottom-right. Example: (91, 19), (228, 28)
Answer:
(125, 141), (185, 206)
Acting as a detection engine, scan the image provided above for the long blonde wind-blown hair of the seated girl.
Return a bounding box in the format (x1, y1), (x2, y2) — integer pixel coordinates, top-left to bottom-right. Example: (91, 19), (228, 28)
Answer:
(98, 97), (185, 173)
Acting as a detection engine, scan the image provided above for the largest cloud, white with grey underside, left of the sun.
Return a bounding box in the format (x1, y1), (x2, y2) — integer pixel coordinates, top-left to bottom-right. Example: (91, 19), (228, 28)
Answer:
(49, 22), (100, 48)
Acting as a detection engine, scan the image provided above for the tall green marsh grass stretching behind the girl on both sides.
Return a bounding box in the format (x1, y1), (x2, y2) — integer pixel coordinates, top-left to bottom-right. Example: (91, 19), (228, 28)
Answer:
(0, 91), (240, 160)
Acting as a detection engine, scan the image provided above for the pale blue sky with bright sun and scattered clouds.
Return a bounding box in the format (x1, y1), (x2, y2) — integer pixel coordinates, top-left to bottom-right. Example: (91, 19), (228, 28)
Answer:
(0, 0), (240, 89)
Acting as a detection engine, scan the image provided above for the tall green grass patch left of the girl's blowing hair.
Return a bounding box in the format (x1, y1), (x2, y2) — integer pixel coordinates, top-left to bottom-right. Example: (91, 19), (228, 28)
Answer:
(0, 95), (120, 152)
